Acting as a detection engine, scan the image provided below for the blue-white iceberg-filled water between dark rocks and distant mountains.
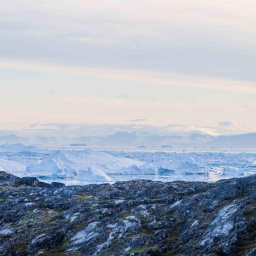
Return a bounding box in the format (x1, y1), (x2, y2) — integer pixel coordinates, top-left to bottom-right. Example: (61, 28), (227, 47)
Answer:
(0, 144), (256, 185)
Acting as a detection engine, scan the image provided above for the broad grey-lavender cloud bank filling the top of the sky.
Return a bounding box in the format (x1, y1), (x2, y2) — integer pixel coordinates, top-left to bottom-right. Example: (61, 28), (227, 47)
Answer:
(0, 0), (256, 81)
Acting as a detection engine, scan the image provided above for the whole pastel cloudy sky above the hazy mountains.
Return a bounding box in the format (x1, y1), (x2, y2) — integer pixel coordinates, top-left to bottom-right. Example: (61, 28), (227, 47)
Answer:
(0, 0), (256, 134)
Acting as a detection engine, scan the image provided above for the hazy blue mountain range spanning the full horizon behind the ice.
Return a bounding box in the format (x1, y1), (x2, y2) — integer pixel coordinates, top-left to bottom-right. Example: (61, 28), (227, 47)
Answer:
(0, 131), (256, 149)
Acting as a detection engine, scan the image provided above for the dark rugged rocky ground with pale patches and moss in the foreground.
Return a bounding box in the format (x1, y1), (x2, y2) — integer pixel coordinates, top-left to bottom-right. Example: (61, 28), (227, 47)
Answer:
(0, 172), (256, 256)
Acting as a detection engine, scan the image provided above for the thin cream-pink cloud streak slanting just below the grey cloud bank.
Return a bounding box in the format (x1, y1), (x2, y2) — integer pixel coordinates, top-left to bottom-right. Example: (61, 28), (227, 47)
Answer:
(0, 58), (256, 95)
